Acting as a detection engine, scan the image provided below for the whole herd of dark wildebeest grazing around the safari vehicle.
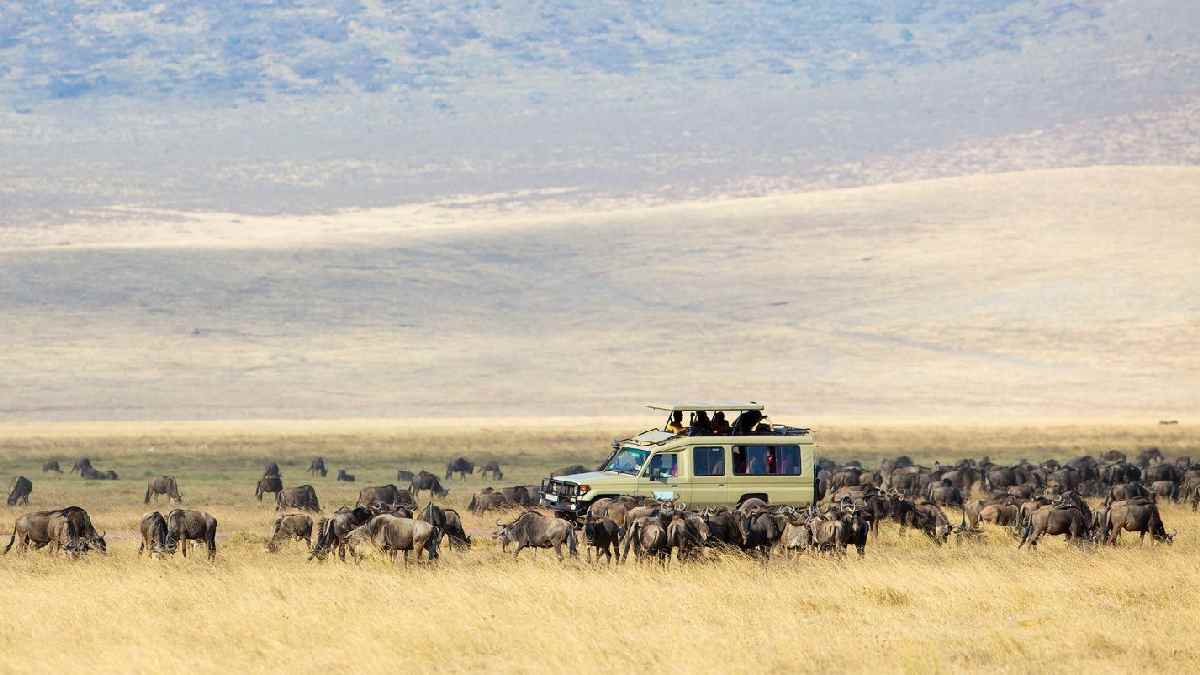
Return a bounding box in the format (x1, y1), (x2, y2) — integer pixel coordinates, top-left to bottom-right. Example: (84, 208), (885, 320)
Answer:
(4, 448), (1200, 565)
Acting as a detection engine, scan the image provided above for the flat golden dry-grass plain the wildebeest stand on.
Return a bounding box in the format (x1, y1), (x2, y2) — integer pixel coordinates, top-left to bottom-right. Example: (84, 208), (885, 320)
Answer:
(0, 419), (1200, 673)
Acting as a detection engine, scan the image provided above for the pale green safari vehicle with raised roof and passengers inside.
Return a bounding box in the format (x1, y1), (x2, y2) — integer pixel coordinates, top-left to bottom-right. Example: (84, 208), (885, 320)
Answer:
(541, 401), (816, 520)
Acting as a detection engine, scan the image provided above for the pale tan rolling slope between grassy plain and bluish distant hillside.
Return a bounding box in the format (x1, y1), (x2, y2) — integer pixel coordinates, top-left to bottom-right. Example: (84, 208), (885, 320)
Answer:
(0, 167), (1200, 419)
